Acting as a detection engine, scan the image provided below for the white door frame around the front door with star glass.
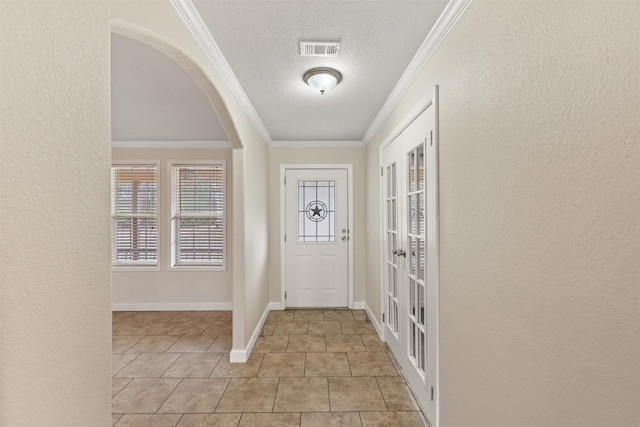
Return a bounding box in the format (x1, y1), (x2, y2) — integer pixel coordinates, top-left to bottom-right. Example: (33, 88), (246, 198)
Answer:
(279, 163), (353, 310)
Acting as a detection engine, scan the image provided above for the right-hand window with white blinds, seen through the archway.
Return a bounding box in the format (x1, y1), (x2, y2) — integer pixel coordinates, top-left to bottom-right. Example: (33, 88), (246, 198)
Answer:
(171, 162), (225, 268)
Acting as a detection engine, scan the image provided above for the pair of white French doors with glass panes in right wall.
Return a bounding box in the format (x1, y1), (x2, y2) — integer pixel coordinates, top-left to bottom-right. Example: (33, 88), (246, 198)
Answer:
(381, 90), (438, 427)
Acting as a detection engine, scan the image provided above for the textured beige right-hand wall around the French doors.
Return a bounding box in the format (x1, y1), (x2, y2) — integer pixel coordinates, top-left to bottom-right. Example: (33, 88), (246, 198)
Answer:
(367, 1), (640, 427)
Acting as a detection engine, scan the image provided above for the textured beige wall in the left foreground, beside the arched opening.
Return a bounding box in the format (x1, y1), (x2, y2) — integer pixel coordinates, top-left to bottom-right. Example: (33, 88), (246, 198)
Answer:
(0, 1), (111, 427)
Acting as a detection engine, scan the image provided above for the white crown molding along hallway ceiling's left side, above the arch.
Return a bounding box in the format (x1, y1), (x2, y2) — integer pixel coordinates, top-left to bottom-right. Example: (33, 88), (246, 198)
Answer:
(170, 0), (271, 144)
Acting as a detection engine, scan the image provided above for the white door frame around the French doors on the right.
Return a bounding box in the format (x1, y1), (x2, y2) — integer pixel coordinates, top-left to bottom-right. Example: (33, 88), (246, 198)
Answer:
(378, 85), (440, 427)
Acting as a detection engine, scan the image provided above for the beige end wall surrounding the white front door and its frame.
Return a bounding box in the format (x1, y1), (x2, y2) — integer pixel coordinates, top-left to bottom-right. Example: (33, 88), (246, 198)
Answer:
(269, 147), (366, 302)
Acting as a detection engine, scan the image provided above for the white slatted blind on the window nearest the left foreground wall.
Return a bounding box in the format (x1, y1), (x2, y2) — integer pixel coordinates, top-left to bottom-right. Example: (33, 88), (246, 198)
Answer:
(111, 165), (158, 265)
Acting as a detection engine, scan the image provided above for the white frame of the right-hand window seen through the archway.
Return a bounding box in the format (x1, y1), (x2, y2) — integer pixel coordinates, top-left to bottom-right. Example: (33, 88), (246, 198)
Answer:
(167, 159), (229, 272)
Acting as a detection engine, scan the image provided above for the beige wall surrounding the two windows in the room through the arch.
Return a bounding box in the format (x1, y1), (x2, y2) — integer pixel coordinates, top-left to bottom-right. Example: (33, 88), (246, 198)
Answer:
(111, 148), (233, 310)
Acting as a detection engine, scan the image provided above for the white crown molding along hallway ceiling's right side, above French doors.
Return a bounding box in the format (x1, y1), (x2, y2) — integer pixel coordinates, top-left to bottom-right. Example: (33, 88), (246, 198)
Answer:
(362, 0), (473, 145)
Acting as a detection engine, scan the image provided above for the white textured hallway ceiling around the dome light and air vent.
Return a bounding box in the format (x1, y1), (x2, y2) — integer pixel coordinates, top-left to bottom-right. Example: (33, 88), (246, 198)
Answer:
(194, 0), (447, 141)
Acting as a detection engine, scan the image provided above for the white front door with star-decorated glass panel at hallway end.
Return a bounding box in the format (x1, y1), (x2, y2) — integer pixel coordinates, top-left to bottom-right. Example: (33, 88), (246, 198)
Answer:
(284, 169), (349, 307)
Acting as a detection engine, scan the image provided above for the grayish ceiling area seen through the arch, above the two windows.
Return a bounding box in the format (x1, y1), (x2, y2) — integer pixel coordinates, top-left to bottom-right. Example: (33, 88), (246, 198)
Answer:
(111, 34), (227, 141)
